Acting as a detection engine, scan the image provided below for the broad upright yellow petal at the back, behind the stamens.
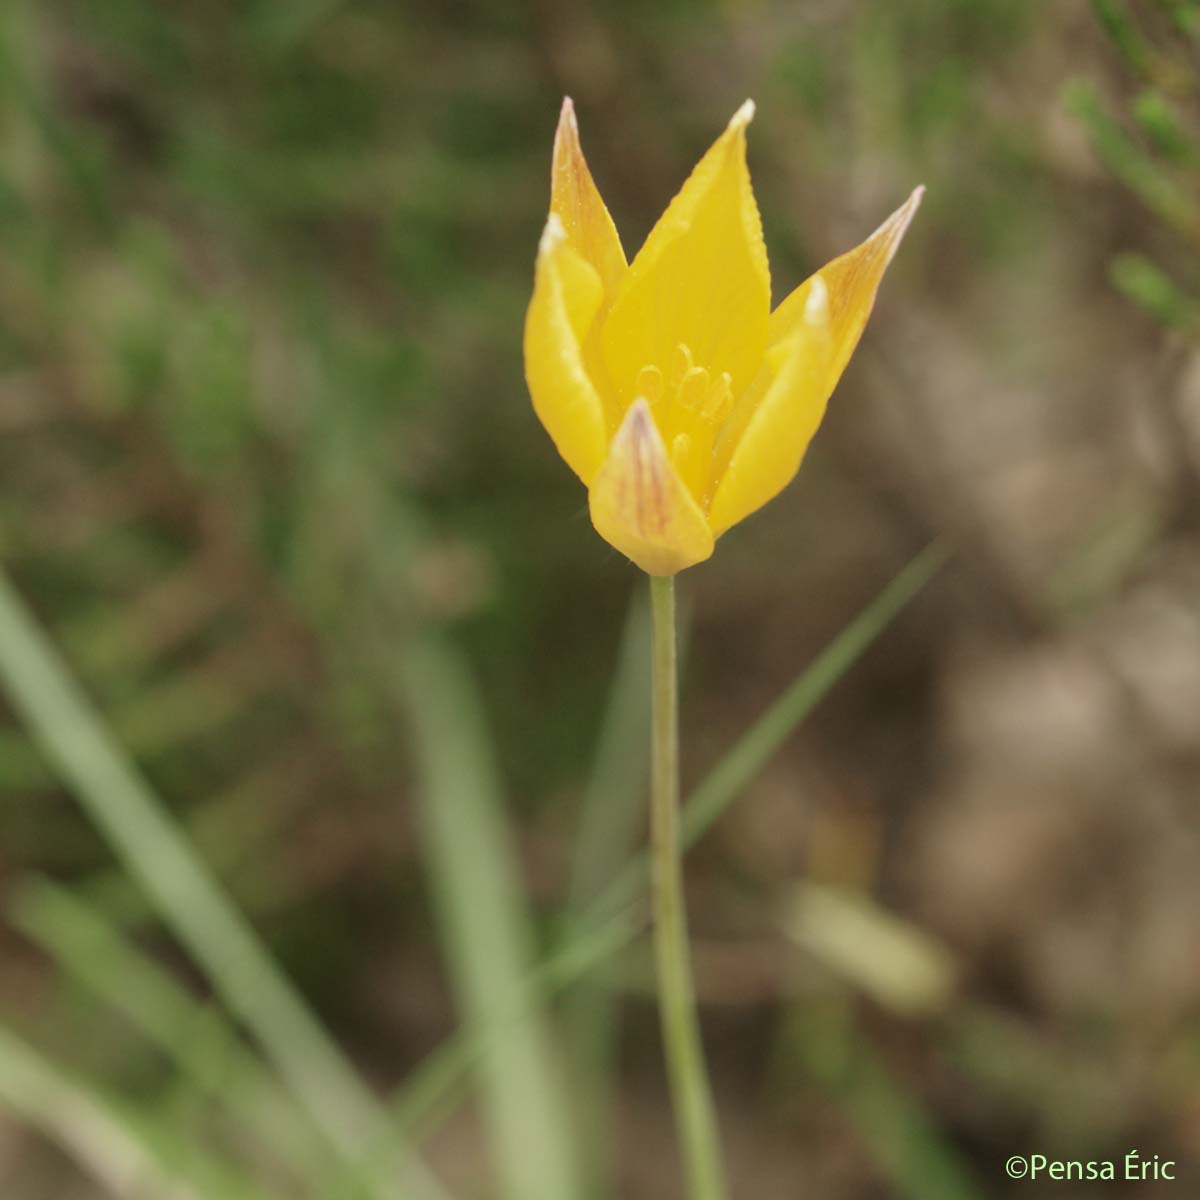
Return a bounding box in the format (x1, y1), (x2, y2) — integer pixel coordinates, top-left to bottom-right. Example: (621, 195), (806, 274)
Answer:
(602, 101), (770, 404)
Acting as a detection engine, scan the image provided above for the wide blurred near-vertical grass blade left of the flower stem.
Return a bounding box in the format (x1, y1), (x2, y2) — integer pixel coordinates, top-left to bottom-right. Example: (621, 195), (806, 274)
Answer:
(397, 637), (580, 1200)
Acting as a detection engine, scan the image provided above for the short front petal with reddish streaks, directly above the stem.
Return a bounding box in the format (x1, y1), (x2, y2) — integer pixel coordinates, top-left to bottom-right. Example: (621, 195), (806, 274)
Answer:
(588, 398), (713, 575)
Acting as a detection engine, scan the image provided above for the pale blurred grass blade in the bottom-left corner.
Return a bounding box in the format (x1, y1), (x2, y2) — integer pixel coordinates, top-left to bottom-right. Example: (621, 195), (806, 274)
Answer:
(0, 1026), (205, 1200)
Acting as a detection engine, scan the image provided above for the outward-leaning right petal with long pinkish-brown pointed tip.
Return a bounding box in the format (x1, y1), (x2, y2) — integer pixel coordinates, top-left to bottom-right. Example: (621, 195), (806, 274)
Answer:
(770, 187), (925, 391)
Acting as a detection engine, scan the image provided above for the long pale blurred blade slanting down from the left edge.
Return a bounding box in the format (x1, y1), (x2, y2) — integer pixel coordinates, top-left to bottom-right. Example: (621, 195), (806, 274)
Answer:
(0, 574), (451, 1196)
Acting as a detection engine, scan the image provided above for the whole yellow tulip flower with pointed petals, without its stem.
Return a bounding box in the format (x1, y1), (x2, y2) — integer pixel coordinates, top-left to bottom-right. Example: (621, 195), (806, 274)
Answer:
(524, 100), (923, 575)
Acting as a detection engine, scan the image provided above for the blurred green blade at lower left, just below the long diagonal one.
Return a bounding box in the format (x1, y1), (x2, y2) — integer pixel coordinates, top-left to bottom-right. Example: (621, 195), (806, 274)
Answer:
(8, 880), (331, 1180)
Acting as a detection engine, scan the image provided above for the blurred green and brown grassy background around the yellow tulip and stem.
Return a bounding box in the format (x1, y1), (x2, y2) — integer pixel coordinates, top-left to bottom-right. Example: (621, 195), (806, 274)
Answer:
(0, 0), (1200, 1200)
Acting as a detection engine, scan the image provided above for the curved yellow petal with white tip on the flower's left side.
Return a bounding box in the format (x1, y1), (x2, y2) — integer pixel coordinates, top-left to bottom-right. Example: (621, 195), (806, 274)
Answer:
(524, 212), (608, 485)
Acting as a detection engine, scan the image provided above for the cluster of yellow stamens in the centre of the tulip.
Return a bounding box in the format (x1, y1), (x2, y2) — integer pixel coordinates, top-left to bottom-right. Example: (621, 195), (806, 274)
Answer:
(635, 342), (733, 510)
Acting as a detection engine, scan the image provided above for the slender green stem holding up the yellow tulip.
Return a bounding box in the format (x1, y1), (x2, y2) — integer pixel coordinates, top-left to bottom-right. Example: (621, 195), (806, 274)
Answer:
(650, 576), (725, 1200)
